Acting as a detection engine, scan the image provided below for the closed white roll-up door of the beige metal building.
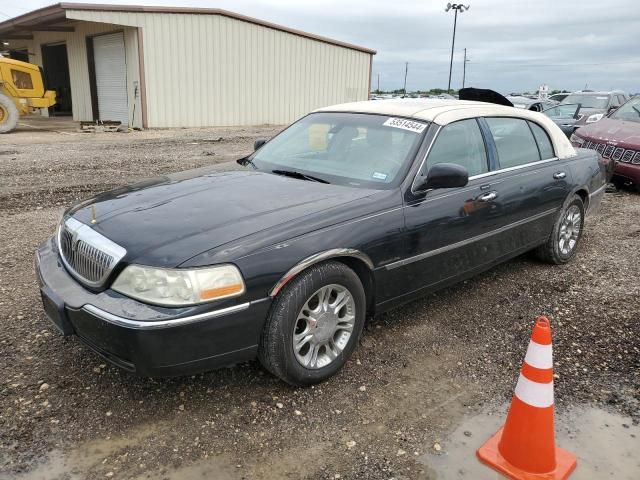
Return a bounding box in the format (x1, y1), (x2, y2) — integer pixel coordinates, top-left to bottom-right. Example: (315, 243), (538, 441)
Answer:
(93, 32), (129, 125)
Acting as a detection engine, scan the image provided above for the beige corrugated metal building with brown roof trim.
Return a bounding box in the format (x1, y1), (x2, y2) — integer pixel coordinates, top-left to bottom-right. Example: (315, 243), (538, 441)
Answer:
(0, 3), (375, 128)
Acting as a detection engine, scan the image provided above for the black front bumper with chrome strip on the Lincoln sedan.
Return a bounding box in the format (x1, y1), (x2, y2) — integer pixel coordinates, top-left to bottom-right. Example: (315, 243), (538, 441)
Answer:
(36, 239), (271, 377)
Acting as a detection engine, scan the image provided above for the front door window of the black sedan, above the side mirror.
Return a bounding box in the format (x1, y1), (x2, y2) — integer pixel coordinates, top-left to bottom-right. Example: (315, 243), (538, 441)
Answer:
(427, 119), (489, 177)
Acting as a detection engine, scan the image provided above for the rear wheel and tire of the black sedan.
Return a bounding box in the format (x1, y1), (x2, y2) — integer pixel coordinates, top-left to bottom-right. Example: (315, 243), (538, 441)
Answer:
(535, 195), (584, 265)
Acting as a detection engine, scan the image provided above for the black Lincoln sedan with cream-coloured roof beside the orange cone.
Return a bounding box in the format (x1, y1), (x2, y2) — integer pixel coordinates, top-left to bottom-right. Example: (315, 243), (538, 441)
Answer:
(36, 100), (604, 385)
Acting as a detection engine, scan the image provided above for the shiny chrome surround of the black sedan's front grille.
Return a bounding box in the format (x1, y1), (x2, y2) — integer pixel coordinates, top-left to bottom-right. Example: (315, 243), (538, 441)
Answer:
(56, 217), (127, 288)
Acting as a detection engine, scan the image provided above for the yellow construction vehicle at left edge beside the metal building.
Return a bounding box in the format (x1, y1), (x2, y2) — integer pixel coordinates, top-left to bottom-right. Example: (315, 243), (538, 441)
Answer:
(0, 55), (56, 133)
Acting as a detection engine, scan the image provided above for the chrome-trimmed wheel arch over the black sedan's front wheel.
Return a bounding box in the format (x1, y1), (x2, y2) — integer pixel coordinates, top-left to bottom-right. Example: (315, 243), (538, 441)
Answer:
(269, 248), (375, 314)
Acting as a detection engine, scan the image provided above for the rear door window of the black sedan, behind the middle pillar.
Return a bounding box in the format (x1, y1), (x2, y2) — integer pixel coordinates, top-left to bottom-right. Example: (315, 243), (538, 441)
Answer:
(486, 117), (540, 168)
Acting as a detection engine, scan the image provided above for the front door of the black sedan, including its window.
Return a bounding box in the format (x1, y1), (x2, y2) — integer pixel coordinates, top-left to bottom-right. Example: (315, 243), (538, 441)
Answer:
(387, 119), (501, 294)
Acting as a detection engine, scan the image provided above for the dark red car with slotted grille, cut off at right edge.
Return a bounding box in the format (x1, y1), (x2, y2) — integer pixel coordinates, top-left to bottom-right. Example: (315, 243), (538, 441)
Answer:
(571, 96), (640, 191)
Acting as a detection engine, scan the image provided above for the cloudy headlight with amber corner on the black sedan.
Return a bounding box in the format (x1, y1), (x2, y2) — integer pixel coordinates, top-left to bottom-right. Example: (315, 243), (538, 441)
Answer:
(111, 265), (245, 306)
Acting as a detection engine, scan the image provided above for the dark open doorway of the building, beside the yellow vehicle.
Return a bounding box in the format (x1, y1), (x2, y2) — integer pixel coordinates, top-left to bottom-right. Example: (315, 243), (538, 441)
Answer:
(41, 43), (72, 116)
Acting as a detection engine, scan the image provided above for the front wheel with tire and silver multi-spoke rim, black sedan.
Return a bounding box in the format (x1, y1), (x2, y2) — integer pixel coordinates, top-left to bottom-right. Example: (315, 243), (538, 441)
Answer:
(258, 261), (366, 386)
